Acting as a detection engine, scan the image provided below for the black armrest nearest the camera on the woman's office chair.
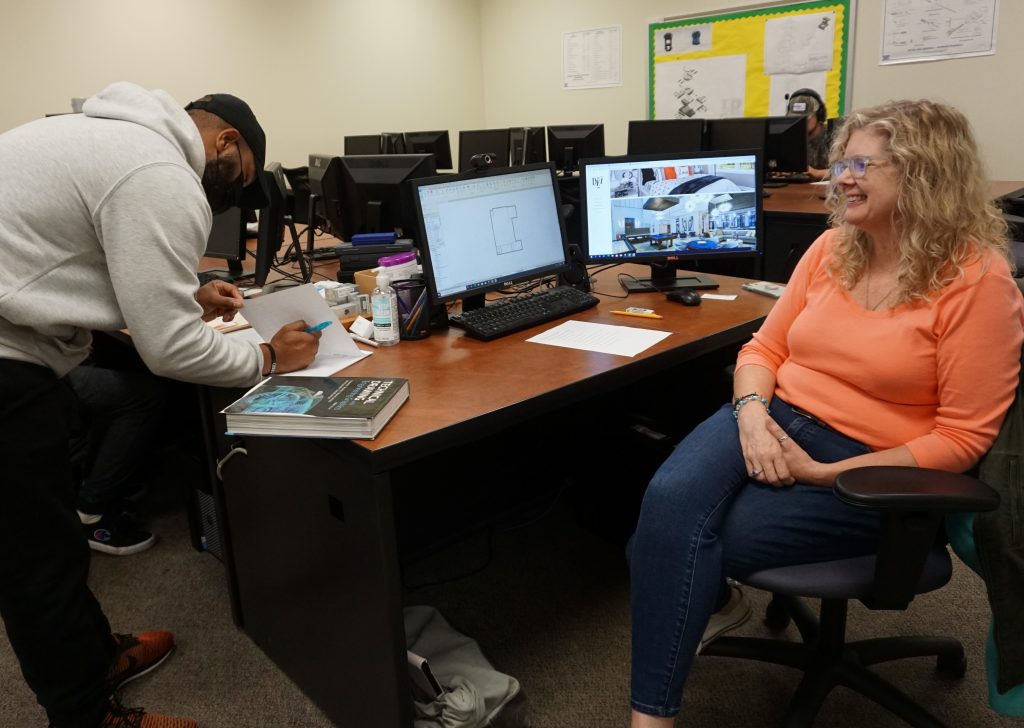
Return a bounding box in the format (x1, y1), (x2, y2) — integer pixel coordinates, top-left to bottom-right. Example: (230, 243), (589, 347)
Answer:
(835, 465), (999, 513)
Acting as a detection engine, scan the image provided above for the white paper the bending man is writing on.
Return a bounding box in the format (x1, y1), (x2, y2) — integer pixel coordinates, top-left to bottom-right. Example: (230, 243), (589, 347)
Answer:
(237, 284), (373, 377)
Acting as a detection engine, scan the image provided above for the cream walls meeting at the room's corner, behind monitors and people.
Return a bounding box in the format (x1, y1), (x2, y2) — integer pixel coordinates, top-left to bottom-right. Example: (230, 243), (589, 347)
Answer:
(0, 0), (1024, 179)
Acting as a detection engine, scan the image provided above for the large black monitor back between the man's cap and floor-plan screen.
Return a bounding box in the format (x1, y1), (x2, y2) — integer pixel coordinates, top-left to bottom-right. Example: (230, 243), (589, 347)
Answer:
(309, 155), (437, 241)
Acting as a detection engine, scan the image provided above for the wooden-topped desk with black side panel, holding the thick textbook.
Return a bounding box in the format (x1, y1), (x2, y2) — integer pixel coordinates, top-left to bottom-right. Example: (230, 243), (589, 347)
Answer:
(207, 266), (774, 728)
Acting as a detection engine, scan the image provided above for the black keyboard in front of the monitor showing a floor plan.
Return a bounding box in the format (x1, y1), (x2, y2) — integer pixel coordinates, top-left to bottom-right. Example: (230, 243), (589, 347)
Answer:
(450, 286), (597, 341)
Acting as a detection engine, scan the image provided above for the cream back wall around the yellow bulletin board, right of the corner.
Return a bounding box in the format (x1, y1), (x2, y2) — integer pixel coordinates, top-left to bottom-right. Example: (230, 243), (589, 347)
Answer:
(479, 0), (1024, 179)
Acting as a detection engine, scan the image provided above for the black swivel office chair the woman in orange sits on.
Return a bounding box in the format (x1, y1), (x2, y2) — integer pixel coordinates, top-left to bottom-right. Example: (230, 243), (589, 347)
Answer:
(701, 466), (999, 728)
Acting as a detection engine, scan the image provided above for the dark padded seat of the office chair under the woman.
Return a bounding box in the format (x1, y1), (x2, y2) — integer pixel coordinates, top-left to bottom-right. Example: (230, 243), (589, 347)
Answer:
(737, 547), (952, 599)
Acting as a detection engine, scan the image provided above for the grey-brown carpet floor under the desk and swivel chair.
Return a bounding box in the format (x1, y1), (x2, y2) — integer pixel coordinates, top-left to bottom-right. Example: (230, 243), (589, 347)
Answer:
(0, 489), (1020, 728)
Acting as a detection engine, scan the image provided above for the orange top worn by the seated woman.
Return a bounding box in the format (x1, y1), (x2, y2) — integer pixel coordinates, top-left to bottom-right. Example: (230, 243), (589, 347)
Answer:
(736, 230), (1024, 472)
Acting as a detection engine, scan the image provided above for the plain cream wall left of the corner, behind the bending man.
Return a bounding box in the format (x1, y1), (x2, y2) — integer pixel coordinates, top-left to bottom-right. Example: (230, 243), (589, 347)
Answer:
(0, 0), (483, 166)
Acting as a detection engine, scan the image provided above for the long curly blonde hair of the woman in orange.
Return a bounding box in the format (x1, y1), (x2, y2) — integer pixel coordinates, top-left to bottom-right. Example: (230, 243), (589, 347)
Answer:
(826, 100), (1013, 303)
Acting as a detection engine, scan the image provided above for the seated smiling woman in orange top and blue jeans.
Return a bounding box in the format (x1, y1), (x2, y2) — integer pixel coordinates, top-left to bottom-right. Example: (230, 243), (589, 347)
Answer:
(630, 101), (1024, 728)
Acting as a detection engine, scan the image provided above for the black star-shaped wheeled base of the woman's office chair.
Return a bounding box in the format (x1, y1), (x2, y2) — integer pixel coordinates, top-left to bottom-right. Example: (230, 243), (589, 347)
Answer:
(701, 595), (967, 728)
